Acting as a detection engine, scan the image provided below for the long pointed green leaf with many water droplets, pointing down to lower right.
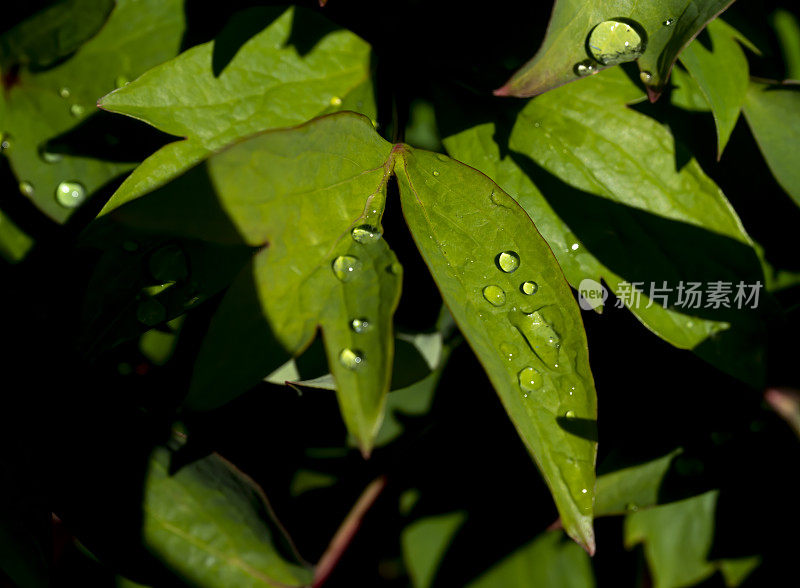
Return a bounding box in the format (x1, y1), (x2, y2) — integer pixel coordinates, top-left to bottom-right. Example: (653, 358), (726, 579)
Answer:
(395, 147), (597, 552)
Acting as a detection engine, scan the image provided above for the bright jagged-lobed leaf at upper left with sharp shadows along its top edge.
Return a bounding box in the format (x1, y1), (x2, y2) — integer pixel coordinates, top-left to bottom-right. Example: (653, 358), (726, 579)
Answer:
(99, 7), (375, 212)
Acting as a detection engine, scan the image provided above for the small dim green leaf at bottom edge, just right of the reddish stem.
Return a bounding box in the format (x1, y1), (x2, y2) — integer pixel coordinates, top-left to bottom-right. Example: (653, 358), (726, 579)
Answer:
(400, 512), (467, 588)
